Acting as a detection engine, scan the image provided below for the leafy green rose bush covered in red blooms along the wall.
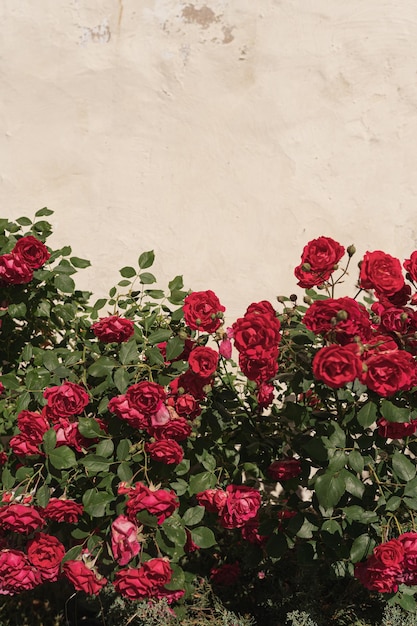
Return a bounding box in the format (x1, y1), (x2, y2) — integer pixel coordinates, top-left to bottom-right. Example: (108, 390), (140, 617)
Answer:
(0, 214), (417, 610)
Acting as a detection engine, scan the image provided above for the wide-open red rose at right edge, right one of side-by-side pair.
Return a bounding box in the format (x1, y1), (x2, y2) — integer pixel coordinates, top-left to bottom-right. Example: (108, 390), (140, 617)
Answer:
(361, 350), (417, 397)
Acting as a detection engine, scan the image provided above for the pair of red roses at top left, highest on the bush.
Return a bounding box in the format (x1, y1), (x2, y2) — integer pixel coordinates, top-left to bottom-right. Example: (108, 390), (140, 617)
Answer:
(0, 235), (50, 285)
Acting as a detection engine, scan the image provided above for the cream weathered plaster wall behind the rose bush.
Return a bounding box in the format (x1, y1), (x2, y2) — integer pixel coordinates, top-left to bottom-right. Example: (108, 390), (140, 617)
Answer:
(0, 0), (417, 318)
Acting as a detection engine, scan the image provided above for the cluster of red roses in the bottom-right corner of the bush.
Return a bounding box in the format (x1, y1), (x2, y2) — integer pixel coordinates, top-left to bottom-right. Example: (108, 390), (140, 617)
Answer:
(355, 532), (417, 593)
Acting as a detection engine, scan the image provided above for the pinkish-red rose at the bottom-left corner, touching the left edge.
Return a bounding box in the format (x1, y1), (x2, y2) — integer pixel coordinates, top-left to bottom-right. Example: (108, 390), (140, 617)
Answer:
(0, 550), (41, 595)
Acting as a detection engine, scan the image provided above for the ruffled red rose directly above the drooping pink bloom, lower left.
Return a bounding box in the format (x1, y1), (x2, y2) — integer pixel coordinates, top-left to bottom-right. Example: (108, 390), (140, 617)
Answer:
(126, 483), (179, 524)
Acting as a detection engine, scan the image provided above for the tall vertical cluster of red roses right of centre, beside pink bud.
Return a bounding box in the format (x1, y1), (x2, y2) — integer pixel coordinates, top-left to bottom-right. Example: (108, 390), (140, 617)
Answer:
(232, 300), (281, 394)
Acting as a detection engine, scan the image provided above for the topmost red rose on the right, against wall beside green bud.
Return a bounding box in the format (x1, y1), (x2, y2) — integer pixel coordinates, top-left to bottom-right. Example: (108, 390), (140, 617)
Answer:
(295, 237), (345, 288)
